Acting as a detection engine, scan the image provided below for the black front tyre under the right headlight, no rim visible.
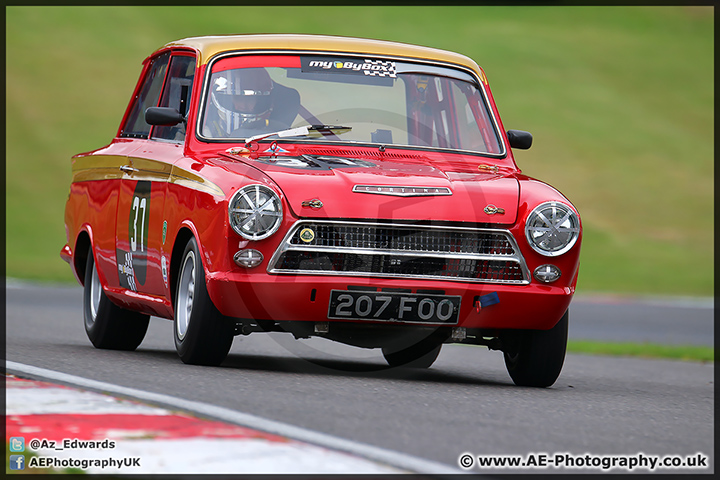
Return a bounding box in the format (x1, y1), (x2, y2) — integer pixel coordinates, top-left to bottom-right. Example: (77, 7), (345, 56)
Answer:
(500, 311), (568, 387)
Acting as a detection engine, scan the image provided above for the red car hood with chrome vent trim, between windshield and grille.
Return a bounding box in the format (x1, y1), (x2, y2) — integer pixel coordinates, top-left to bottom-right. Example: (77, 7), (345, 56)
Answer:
(231, 156), (519, 224)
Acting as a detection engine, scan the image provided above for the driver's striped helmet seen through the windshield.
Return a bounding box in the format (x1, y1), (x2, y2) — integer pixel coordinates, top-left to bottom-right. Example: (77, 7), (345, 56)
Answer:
(211, 68), (273, 133)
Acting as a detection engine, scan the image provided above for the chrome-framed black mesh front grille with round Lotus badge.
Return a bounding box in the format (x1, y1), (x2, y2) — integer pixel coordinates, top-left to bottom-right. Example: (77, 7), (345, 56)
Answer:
(268, 220), (529, 284)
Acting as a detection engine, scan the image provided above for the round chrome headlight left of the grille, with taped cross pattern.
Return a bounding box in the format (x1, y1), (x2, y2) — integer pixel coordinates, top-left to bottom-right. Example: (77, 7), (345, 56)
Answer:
(228, 185), (282, 240)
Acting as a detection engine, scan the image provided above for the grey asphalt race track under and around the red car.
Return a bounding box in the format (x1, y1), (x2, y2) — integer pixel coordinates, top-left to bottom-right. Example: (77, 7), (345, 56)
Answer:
(6, 283), (714, 473)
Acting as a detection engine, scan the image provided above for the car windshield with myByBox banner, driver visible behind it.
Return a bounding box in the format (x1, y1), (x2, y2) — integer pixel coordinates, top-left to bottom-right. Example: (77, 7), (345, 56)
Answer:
(198, 55), (503, 155)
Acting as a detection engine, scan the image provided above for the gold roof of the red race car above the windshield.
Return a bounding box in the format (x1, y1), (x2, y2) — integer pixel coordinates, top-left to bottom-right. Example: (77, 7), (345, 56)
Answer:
(163, 34), (482, 75)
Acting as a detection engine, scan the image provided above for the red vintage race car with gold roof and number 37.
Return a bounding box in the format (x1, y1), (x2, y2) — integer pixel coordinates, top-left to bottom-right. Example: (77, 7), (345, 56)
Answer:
(61, 35), (582, 386)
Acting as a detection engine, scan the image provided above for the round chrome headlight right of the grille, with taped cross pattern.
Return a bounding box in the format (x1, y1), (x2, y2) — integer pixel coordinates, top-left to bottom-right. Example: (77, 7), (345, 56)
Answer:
(525, 202), (580, 257)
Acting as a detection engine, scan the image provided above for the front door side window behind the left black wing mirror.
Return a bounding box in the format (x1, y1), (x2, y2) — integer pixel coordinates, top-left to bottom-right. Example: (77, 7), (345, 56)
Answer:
(152, 55), (195, 141)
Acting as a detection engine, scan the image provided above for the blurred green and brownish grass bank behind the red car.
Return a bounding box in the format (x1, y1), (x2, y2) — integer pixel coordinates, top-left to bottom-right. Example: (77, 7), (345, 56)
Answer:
(6, 6), (714, 296)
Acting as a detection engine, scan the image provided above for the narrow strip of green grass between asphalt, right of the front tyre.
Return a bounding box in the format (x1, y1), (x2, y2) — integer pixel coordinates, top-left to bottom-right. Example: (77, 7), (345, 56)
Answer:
(567, 340), (715, 362)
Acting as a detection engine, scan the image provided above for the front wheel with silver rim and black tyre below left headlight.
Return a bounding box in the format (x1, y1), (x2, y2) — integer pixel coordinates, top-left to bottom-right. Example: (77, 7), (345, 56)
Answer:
(173, 237), (235, 365)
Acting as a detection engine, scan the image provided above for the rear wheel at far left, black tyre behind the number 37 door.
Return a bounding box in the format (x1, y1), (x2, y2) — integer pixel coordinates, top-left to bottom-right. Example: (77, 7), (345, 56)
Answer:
(83, 249), (150, 350)
